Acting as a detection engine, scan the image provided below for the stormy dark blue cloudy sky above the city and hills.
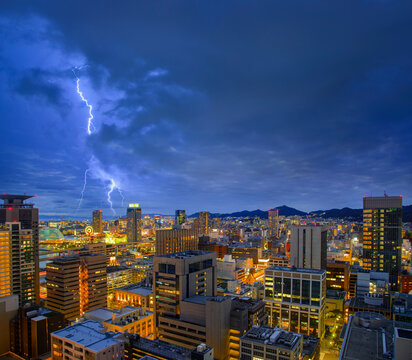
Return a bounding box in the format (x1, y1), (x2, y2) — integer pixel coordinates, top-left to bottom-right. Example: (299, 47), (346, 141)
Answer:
(0, 0), (412, 216)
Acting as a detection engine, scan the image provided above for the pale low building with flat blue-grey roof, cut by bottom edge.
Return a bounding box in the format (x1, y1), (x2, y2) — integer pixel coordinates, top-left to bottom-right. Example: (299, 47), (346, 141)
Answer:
(51, 320), (124, 360)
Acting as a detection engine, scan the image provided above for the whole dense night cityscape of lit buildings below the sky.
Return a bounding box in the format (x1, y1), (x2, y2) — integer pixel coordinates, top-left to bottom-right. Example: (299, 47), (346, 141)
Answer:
(0, 194), (412, 360)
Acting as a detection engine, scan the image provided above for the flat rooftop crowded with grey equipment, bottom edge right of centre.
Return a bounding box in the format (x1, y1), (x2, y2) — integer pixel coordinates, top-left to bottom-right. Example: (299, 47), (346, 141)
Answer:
(241, 326), (303, 350)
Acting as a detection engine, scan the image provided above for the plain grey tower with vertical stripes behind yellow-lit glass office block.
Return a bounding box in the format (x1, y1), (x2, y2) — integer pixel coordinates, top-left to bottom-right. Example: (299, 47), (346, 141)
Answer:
(290, 225), (328, 270)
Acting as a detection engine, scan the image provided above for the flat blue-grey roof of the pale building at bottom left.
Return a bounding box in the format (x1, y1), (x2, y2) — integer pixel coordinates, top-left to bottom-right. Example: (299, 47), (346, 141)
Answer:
(52, 320), (121, 352)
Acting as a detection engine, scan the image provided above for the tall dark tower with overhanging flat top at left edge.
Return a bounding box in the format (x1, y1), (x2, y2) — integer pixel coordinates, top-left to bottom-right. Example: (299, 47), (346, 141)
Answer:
(0, 194), (40, 305)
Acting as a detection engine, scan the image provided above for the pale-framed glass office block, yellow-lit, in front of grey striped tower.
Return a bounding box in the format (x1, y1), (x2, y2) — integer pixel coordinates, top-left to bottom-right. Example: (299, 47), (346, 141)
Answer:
(264, 266), (326, 338)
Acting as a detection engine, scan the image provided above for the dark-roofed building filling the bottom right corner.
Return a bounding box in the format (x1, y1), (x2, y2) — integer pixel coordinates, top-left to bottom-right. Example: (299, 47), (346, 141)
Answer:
(339, 311), (412, 360)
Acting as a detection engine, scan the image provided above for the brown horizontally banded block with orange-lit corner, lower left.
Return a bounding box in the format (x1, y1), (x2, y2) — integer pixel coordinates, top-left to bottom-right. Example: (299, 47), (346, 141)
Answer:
(46, 254), (107, 320)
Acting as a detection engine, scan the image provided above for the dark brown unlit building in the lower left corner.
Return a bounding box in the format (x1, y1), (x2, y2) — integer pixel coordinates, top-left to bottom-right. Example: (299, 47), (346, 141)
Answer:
(10, 305), (66, 360)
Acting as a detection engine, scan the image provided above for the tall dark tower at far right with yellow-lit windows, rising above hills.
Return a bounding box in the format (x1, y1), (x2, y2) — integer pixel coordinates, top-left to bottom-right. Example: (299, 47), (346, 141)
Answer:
(363, 196), (402, 291)
